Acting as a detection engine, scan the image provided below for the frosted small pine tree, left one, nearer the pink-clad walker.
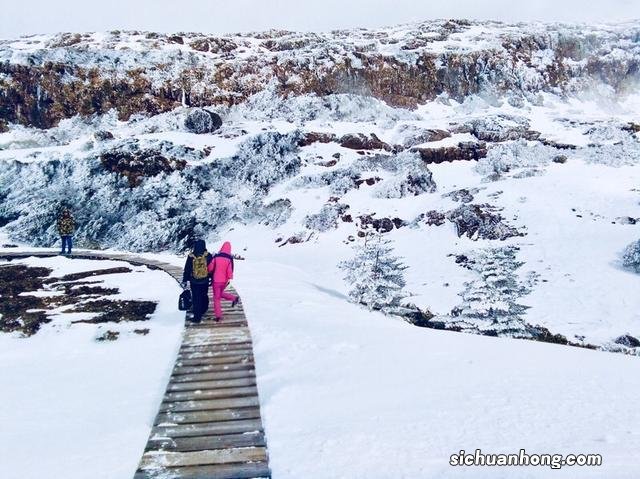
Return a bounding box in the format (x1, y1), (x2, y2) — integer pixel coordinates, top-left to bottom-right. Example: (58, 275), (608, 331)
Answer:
(339, 233), (407, 314)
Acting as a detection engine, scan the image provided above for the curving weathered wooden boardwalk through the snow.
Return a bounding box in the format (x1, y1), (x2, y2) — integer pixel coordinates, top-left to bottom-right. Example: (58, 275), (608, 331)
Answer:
(0, 252), (271, 479)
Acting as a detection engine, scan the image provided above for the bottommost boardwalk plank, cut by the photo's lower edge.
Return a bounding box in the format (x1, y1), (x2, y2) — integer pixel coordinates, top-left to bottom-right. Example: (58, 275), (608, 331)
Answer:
(134, 462), (271, 479)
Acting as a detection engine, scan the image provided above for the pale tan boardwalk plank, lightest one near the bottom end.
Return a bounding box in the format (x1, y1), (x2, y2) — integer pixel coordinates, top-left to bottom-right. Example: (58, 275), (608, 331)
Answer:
(140, 447), (267, 470)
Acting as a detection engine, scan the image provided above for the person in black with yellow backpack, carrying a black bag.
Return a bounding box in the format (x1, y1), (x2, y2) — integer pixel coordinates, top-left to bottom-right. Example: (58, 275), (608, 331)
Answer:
(182, 240), (213, 323)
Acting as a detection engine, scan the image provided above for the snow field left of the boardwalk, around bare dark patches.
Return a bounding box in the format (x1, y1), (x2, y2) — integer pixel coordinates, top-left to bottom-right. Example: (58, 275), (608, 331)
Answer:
(0, 257), (184, 479)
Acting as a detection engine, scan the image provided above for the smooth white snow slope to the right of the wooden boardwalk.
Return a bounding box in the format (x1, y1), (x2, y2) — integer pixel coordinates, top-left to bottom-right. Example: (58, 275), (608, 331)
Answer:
(221, 229), (640, 479)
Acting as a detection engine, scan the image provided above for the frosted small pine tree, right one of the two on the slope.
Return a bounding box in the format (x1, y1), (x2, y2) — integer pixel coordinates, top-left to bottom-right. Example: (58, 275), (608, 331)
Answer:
(452, 247), (531, 337)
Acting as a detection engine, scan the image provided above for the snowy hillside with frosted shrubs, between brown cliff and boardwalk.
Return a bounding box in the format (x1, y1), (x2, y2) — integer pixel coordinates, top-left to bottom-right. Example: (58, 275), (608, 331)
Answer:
(0, 82), (640, 352)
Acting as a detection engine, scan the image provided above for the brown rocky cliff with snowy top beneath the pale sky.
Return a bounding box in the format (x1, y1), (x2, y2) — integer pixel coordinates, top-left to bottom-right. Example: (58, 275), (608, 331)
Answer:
(0, 21), (640, 130)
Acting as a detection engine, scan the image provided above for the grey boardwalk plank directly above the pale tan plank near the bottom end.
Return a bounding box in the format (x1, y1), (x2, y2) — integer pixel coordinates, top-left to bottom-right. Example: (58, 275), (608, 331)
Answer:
(146, 432), (267, 452)
